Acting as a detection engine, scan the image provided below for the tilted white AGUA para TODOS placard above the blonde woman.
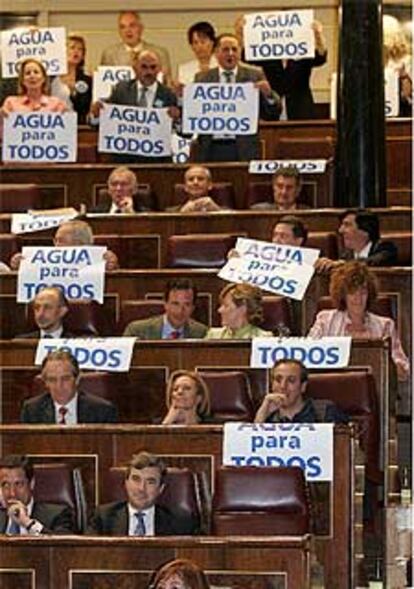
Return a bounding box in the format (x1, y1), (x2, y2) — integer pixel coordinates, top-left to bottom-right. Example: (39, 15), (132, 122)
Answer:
(218, 237), (319, 300)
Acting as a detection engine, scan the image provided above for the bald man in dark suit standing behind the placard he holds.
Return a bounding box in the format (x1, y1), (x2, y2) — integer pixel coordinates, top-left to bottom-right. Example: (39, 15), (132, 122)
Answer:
(91, 50), (180, 164)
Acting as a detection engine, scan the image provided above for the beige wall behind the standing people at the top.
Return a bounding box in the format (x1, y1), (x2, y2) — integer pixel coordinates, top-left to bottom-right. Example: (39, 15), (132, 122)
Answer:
(1, 0), (405, 102)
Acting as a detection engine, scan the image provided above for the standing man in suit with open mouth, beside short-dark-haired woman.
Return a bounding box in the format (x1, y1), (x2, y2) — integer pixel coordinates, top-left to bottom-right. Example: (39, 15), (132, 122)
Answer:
(194, 33), (280, 162)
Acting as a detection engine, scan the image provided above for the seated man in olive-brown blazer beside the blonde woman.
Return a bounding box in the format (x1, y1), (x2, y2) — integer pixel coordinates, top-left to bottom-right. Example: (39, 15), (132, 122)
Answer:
(123, 278), (207, 339)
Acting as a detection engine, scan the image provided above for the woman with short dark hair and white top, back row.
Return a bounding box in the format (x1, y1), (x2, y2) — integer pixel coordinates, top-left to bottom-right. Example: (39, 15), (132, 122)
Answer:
(178, 21), (217, 84)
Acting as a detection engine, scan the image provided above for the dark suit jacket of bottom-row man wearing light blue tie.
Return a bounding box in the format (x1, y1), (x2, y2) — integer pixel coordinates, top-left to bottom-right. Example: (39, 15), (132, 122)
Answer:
(87, 501), (197, 536)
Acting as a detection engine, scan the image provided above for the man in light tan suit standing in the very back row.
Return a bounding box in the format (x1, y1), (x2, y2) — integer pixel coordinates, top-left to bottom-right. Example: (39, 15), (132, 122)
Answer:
(101, 10), (171, 82)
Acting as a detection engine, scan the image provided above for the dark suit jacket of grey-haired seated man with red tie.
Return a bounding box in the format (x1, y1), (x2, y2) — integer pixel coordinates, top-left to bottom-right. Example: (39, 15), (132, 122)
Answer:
(20, 391), (118, 423)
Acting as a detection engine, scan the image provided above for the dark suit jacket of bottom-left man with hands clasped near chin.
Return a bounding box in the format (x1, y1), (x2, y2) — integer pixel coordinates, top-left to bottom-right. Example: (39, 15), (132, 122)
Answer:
(0, 503), (75, 534)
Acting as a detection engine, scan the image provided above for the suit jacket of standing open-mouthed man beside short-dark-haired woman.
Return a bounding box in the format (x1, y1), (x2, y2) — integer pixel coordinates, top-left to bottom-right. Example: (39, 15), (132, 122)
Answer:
(194, 63), (280, 162)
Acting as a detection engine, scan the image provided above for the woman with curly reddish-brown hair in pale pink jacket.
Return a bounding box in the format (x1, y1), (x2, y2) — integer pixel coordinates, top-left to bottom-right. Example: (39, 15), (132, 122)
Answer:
(308, 260), (410, 381)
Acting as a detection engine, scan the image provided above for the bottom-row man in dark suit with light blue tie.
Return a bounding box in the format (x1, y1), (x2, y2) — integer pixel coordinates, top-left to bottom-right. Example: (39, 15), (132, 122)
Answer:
(87, 452), (197, 536)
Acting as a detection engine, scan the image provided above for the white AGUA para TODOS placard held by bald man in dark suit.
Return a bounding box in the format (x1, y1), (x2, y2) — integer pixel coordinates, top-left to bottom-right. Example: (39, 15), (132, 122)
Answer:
(98, 104), (172, 158)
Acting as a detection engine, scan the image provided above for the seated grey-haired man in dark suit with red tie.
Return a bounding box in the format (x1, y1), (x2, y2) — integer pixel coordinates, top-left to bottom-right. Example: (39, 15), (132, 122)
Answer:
(20, 350), (118, 425)
